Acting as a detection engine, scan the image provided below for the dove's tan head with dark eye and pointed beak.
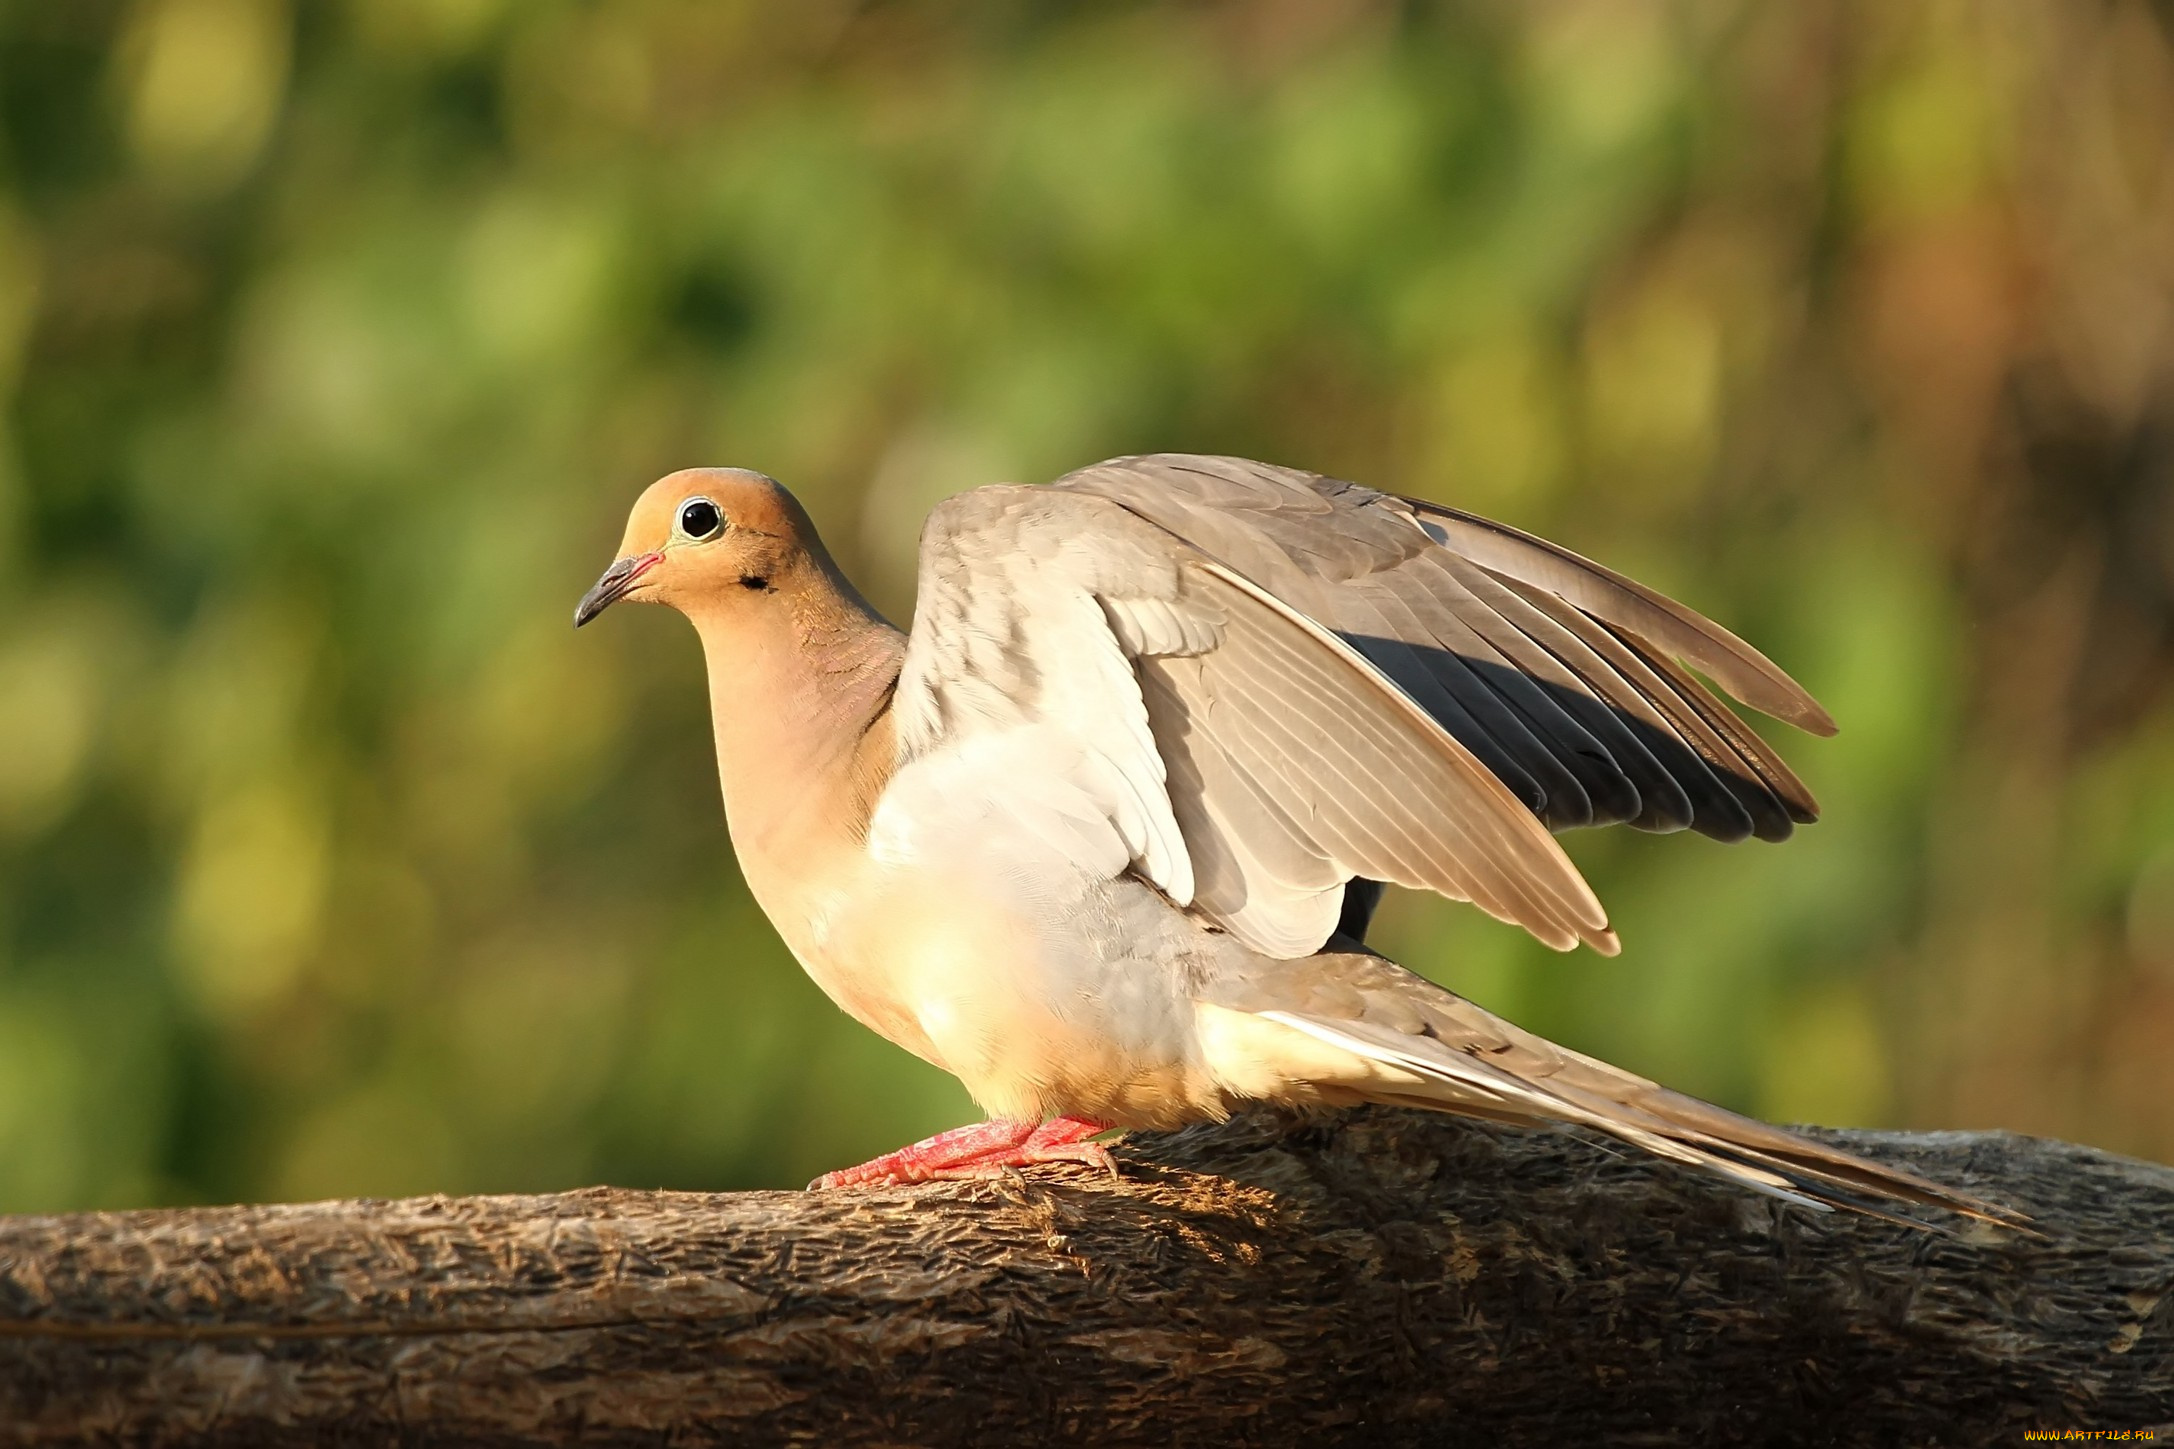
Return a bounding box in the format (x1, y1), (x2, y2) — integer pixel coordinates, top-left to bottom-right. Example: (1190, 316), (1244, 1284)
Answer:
(574, 467), (828, 628)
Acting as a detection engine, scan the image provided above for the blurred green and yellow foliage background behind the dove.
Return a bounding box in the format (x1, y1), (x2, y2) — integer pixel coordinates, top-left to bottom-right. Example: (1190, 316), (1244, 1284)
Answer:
(0, 0), (2174, 1210)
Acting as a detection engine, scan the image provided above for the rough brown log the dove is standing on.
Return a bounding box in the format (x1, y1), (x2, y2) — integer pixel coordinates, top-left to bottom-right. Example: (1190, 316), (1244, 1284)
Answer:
(0, 1110), (2174, 1449)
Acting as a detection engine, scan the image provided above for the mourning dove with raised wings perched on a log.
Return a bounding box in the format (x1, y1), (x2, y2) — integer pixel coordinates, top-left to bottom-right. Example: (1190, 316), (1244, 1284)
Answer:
(574, 454), (2013, 1221)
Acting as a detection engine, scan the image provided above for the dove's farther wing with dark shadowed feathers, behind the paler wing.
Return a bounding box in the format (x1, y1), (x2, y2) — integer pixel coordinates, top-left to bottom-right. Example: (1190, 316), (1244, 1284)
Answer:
(1054, 454), (1835, 841)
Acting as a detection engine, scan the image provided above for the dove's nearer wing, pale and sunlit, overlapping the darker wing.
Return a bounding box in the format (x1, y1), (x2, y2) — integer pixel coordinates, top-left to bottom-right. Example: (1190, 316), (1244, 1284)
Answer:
(874, 487), (1615, 958)
